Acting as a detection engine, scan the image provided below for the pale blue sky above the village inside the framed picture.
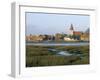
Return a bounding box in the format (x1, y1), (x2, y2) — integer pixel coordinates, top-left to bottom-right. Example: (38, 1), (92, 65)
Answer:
(25, 12), (90, 35)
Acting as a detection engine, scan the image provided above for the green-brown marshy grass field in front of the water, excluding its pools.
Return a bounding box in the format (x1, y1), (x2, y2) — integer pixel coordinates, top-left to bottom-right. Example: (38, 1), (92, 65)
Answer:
(26, 45), (89, 67)
